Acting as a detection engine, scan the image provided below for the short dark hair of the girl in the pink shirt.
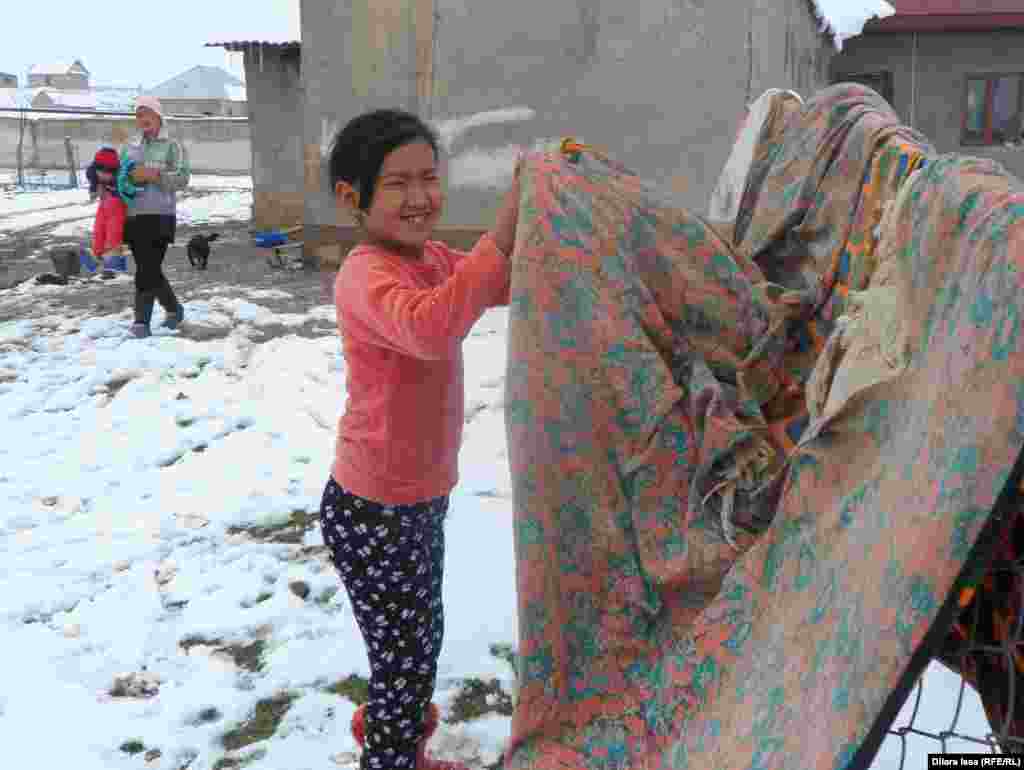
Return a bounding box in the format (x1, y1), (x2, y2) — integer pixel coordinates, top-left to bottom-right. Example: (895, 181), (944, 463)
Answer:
(328, 110), (437, 211)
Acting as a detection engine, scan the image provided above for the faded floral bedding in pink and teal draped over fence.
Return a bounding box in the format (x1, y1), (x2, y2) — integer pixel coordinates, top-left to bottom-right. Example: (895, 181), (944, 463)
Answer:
(506, 85), (1024, 770)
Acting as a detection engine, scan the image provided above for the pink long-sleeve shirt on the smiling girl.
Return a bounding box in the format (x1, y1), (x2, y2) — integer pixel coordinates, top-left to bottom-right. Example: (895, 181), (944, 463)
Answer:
(333, 234), (509, 505)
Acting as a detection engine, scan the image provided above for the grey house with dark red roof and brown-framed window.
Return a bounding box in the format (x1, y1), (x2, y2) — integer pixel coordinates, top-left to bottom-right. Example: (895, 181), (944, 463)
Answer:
(831, 0), (1024, 177)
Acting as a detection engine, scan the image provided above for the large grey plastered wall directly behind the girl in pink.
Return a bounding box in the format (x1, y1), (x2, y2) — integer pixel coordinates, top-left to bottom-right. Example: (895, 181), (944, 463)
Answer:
(302, 0), (831, 264)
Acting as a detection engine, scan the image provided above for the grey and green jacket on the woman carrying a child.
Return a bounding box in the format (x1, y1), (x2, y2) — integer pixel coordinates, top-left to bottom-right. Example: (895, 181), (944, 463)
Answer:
(118, 126), (191, 217)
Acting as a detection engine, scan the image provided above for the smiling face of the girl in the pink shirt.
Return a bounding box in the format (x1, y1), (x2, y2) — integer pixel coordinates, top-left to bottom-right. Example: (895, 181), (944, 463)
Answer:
(336, 141), (444, 258)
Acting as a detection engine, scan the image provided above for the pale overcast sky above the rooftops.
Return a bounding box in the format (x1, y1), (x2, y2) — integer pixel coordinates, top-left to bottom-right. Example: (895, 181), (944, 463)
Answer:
(0, 0), (885, 88)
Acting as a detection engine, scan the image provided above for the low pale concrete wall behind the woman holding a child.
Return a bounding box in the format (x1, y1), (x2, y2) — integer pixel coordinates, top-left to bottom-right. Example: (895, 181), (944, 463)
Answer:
(0, 113), (252, 174)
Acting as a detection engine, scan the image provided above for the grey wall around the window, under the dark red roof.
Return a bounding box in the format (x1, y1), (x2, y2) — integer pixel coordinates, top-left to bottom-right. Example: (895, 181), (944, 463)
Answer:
(833, 31), (1024, 178)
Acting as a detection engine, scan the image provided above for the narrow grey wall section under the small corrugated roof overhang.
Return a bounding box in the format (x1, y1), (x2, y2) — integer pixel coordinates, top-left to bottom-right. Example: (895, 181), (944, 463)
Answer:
(245, 48), (304, 228)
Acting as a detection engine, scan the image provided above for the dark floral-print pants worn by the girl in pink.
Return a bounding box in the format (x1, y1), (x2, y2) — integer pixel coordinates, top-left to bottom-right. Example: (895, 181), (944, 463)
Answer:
(321, 478), (449, 770)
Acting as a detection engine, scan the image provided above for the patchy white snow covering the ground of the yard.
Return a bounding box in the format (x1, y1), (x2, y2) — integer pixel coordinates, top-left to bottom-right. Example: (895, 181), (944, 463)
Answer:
(0, 159), (999, 770)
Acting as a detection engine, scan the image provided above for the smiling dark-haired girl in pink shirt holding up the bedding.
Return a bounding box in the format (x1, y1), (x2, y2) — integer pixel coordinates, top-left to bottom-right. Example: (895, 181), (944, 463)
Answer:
(321, 110), (519, 770)
